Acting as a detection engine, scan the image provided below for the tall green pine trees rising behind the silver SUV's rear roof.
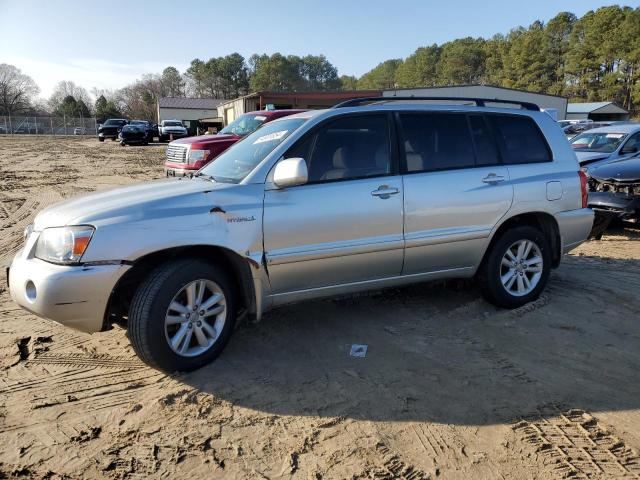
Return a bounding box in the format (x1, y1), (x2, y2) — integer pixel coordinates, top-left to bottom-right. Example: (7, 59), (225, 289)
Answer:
(356, 5), (640, 111)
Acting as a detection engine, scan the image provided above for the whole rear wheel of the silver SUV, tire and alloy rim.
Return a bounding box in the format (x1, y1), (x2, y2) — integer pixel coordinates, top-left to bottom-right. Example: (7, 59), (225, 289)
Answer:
(479, 226), (551, 308)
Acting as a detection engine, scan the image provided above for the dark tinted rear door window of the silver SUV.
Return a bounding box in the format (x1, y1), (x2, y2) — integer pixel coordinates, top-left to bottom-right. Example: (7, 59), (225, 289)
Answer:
(400, 112), (475, 173)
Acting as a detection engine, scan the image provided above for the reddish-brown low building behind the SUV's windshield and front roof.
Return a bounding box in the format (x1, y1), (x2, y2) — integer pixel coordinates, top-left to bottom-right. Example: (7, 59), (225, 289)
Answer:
(218, 90), (382, 125)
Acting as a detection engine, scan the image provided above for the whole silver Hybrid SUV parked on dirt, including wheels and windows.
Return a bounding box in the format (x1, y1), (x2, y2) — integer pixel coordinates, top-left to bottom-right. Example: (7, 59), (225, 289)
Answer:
(8, 98), (593, 371)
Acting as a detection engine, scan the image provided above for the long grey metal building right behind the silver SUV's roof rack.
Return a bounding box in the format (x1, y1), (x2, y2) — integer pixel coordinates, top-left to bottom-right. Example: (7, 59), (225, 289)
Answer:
(383, 85), (568, 120)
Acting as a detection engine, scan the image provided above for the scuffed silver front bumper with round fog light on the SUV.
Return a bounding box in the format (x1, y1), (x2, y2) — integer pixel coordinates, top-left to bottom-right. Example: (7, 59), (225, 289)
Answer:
(7, 251), (130, 333)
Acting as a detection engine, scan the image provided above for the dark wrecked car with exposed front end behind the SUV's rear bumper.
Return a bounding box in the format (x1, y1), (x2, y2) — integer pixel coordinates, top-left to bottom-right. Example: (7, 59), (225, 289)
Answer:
(589, 153), (640, 239)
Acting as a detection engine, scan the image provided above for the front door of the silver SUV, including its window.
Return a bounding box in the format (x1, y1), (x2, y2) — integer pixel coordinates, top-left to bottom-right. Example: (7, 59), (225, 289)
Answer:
(263, 113), (404, 295)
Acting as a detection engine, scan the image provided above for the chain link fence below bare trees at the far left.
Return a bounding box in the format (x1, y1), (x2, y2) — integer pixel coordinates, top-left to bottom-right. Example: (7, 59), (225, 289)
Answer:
(0, 115), (98, 135)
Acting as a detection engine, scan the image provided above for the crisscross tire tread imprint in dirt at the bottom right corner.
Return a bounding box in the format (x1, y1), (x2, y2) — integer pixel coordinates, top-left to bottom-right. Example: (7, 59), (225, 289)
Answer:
(513, 405), (640, 480)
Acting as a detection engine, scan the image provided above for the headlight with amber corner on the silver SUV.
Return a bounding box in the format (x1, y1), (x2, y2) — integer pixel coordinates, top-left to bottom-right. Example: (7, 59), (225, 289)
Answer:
(36, 225), (94, 264)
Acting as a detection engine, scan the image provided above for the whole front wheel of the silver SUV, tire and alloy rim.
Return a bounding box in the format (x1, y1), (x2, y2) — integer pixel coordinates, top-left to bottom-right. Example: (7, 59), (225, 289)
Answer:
(128, 259), (236, 372)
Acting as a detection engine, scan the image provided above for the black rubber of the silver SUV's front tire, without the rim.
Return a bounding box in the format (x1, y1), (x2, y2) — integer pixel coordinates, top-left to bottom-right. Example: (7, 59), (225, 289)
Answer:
(127, 259), (237, 372)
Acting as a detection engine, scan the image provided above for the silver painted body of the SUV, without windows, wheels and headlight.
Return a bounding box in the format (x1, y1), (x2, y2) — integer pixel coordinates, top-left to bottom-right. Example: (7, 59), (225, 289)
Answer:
(9, 104), (593, 332)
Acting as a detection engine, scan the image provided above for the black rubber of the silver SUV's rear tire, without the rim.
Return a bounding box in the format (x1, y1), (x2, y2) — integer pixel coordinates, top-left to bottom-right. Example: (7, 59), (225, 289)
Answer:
(478, 225), (551, 308)
